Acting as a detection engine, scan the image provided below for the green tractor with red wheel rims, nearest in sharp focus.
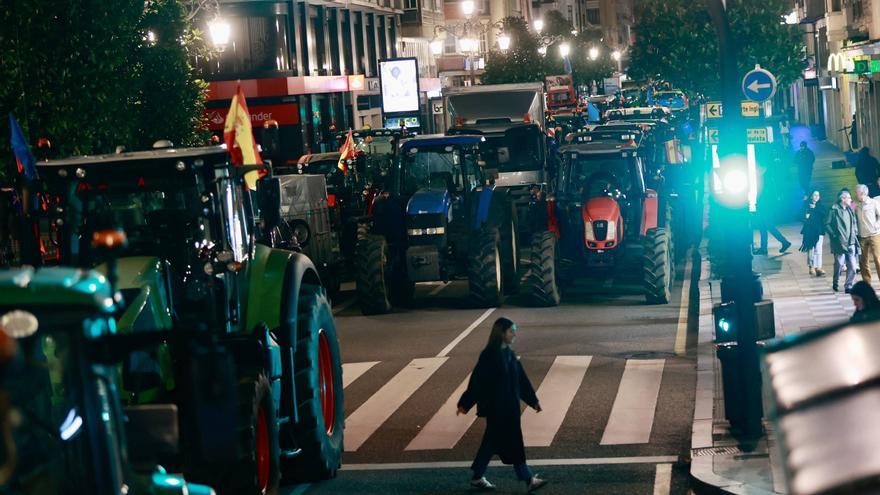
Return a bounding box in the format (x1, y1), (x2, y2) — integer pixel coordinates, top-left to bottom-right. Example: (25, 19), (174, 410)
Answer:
(38, 147), (343, 495)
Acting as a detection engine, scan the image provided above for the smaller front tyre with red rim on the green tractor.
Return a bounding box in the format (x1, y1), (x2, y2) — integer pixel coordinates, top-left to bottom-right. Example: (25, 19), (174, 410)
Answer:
(211, 372), (281, 495)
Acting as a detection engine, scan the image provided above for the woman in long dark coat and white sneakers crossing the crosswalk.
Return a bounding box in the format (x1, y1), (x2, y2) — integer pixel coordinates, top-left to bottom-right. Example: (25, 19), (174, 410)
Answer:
(456, 318), (547, 492)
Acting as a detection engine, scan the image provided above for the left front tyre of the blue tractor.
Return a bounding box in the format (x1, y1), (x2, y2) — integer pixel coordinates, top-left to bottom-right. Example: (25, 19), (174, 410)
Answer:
(355, 234), (391, 315)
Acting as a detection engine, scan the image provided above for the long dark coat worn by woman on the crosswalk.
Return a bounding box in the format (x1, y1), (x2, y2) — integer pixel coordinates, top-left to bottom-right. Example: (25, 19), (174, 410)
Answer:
(458, 347), (538, 464)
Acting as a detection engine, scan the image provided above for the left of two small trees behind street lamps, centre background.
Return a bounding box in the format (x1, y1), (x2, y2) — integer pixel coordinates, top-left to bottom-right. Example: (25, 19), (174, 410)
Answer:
(480, 17), (544, 84)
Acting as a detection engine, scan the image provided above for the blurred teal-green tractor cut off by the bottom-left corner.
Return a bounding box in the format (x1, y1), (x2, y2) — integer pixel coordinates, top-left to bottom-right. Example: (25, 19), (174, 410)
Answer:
(0, 268), (220, 495)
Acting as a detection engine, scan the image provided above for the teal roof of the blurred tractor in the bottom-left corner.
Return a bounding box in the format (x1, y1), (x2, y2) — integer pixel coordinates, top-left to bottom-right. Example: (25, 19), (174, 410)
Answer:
(0, 268), (116, 313)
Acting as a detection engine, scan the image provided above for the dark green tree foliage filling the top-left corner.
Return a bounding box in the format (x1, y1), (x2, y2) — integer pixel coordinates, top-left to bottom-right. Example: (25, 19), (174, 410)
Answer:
(0, 0), (204, 183)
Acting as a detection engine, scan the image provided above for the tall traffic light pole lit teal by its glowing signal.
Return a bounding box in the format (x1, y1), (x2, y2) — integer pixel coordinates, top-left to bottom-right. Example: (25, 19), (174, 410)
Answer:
(705, 0), (763, 439)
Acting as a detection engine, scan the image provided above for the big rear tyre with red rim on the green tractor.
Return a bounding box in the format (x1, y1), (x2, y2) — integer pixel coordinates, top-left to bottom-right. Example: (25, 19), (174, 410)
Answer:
(281, 285), (345, 482)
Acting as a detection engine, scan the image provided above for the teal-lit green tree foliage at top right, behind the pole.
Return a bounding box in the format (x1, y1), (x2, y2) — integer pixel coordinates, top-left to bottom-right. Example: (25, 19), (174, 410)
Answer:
(630, 0), (805, 96)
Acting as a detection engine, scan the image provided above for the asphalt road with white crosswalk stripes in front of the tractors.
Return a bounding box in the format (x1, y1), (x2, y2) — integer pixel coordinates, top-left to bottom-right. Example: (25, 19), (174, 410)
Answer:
(282, 254), (697, 494)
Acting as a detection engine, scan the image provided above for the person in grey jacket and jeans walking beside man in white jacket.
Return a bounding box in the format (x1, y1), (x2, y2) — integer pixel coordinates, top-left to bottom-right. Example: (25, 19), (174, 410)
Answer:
(825, 191), (859, 294)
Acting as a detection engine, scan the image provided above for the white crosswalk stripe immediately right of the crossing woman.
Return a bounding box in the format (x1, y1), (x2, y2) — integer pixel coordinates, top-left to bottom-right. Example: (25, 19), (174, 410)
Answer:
(522, 356), (593, 447)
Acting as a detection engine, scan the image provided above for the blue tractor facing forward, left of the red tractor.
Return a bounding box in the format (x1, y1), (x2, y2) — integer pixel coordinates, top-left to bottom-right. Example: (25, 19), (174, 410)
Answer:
(355, 135), (517, 314)
